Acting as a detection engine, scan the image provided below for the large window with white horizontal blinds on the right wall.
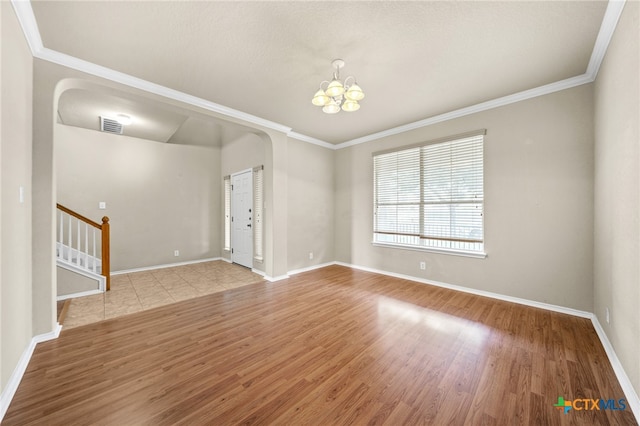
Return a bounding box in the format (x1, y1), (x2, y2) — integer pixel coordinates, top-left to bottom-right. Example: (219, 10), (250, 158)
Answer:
(373, 131), (485, 256)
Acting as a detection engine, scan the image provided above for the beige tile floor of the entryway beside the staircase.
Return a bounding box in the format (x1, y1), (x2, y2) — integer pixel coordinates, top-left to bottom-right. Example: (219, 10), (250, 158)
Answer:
(63, 260), (263, 329)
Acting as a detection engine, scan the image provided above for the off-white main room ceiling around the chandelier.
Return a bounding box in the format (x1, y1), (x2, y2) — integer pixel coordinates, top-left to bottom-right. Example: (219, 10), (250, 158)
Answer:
(31, 1), (615, 144)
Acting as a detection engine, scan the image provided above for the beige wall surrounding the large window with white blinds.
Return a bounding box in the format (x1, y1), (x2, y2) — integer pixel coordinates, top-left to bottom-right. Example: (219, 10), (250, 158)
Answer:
(335, 85), (593, 311)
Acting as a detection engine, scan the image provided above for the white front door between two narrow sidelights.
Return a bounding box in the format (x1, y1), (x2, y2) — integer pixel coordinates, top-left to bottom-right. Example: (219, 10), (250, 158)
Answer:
(231, 170), (253, 268)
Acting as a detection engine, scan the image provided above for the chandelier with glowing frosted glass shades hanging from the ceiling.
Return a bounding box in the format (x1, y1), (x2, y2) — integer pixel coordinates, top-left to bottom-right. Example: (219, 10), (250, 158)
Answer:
(311, 59), (364, 114)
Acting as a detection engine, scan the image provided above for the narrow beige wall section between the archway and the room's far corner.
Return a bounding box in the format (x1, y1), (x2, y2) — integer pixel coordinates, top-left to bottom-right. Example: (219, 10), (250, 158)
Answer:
(287, 139), (335, 271)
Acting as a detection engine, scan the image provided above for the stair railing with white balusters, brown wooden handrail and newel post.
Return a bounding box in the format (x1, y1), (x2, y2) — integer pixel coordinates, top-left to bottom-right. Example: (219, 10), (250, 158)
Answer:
(56, 204), (111, 299)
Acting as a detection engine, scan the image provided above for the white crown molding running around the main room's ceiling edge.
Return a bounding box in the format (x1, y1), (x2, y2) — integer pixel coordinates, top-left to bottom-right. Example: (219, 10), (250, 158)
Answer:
(11, 0), (626, 150)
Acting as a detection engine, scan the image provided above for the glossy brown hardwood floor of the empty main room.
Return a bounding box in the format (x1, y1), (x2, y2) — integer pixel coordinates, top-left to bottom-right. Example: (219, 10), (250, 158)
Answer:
(3, 266), (637, 425)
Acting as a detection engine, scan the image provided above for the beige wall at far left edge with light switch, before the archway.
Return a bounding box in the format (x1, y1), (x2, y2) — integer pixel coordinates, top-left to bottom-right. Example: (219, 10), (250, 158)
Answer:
(0, 1), (33, 390)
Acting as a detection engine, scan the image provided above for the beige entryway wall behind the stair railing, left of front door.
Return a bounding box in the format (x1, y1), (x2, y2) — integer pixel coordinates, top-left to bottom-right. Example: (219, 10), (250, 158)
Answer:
(55, 124), (222, 271)
